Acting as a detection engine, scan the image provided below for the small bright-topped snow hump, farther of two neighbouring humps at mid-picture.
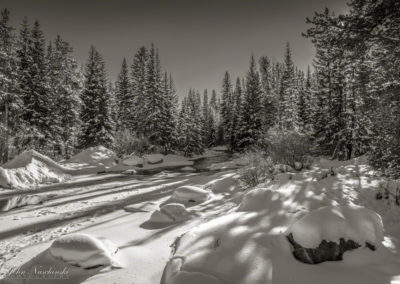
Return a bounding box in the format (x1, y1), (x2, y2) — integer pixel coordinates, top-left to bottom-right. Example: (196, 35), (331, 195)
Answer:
(170, 185), (210, 204)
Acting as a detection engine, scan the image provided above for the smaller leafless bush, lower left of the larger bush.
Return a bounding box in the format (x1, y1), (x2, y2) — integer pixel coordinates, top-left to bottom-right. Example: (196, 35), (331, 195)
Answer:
(239, 151), (273, 187)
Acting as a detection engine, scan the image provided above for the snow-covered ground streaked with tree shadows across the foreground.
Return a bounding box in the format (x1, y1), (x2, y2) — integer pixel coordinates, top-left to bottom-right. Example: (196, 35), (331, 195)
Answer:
(0, 154), (400, 284)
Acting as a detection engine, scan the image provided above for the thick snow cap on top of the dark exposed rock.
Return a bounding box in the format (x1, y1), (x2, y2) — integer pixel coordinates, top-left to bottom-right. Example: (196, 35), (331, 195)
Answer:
(287, 205), (383, 248)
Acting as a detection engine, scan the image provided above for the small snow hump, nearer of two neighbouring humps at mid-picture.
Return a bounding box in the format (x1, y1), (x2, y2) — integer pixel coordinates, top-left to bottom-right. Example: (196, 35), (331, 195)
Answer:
(149, 203), (191, 223)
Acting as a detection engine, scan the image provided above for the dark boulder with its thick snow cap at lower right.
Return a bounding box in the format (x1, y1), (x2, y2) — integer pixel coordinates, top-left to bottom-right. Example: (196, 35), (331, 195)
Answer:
(287, 205), (383, 264)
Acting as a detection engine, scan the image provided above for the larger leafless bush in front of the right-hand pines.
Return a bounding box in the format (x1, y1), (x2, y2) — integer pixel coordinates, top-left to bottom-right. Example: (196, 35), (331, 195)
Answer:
(260, 129), (312, 168)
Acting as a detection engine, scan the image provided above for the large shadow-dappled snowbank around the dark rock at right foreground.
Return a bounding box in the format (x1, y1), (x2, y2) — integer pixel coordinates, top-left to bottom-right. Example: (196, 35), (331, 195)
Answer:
(161, 158), (400, 284)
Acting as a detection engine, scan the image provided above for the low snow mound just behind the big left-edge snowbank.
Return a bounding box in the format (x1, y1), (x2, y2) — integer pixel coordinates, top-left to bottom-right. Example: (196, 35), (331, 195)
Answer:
(65, 146), (118, 167)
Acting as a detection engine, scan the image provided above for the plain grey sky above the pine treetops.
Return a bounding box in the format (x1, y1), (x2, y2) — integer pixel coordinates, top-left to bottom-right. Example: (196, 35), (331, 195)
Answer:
(0, 0), (348, 96)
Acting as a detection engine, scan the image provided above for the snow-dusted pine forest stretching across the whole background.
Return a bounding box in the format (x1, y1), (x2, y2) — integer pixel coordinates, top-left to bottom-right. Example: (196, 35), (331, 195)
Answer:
(0, 0), (400, 177)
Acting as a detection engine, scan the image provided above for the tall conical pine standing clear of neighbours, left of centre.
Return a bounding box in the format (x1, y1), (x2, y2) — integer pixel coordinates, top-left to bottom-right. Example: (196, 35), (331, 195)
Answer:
(80, 46), (114, 148)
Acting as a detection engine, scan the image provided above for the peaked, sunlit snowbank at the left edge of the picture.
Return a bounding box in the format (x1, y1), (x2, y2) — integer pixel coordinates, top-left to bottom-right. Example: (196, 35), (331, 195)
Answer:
(0, 150), (73, 189)
